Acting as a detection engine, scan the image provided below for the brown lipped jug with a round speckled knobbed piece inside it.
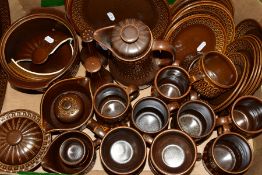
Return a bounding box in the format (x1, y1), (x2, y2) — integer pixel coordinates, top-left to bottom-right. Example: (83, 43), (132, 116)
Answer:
(41, 78), (93, 132)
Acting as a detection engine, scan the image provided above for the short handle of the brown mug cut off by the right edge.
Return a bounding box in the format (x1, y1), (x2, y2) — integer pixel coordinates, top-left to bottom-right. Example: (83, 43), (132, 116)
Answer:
(216, 115), (232, 135)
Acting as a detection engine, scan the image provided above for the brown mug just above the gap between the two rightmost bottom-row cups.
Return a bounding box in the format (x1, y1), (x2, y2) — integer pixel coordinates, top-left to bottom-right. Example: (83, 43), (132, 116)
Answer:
(171, 100), (216, 144)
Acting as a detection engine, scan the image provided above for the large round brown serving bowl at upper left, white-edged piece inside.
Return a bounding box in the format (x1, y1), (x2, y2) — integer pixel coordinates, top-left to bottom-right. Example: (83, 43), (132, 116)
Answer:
(0, 13), (79, 91)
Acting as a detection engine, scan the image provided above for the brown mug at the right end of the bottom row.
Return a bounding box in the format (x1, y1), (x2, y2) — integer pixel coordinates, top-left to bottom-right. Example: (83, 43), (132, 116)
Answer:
(202, 133), (253, 175)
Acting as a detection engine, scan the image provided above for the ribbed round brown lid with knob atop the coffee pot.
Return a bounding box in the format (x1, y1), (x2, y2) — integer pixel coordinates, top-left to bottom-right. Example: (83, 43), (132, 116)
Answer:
(111, 19), (152, 58)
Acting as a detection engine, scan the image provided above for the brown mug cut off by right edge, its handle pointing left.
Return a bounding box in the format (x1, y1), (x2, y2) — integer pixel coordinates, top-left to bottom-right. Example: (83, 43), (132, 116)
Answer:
(216, 96), (262, 137)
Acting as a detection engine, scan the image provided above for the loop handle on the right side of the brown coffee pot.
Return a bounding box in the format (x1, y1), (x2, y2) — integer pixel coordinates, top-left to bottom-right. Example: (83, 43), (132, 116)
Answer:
(151, 40), (175, 67)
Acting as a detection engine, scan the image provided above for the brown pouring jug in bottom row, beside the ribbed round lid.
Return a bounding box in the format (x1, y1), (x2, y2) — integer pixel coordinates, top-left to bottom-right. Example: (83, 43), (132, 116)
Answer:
(41, 131), (101, 174)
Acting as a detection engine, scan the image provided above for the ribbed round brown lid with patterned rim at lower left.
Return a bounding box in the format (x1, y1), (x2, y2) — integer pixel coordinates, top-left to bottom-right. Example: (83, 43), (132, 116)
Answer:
(0, 109), (51, 173)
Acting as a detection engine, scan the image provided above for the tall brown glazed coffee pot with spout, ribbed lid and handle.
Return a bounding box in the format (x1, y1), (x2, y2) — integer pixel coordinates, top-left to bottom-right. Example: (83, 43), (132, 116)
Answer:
(94, 19), (175, 86)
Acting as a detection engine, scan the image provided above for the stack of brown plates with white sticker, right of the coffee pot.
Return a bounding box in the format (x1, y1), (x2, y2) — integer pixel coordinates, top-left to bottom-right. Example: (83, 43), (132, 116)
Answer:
(164, 0), (235, 65)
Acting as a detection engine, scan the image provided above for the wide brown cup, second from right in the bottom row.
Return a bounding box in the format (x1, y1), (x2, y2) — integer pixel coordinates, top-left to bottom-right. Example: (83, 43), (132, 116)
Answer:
(148, 129), (198, 175)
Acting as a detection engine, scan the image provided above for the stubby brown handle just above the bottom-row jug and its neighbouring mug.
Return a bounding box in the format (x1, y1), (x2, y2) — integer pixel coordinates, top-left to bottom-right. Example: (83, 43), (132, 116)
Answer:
(87, 118), (110, 139)
